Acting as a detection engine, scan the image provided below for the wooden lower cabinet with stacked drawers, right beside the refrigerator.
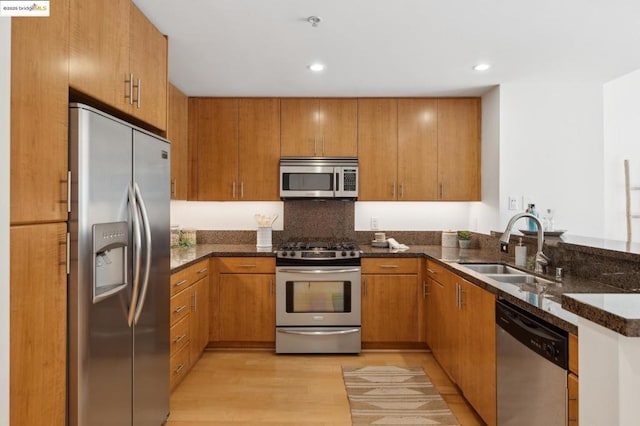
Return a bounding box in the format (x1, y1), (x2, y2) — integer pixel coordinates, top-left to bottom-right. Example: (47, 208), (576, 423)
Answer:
(169, 259), (209, 389)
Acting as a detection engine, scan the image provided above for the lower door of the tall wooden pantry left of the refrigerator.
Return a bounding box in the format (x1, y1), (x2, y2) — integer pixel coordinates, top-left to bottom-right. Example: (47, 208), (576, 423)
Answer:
(9, 223), (67, 426)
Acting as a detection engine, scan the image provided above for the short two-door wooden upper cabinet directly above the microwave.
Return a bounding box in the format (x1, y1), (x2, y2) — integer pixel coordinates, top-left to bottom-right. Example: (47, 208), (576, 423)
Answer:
(281, 98), (358, 157)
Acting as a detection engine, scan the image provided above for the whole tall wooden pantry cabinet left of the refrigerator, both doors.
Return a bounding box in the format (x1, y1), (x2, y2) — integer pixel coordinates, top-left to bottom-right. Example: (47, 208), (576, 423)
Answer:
(9, 0), (69, 426)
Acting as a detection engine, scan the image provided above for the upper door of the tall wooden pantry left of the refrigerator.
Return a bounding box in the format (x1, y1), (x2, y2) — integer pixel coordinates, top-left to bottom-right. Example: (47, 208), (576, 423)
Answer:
(10, 0), (69, 224)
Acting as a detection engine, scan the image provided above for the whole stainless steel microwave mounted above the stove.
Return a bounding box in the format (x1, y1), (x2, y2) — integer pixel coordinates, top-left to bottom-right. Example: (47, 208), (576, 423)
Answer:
(280, 157), (358, 200)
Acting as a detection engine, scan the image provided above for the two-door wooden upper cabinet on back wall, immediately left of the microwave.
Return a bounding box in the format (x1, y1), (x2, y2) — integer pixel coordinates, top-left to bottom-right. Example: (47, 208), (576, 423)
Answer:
(188, 98), (280, 201)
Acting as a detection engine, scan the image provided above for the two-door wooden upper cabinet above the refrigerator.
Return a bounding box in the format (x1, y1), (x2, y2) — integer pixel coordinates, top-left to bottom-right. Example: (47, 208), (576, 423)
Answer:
(69, 0), (167, 130)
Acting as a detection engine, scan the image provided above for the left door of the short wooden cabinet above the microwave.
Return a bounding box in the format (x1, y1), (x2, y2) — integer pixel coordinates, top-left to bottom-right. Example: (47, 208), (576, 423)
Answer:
(280, 98), (321, 157)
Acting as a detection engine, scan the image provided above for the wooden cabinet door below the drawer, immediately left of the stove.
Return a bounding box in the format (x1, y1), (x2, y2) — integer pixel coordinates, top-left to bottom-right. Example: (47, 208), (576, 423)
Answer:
(219, 274), (276, 342)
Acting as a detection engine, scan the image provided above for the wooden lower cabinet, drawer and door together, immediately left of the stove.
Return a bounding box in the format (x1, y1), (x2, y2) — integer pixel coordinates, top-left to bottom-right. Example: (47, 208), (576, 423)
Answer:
(210, 257), (276, 348)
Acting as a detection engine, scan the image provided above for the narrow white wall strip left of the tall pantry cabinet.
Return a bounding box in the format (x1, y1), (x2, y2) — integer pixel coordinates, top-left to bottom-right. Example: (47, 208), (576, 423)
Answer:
(0, 18), (11, 425)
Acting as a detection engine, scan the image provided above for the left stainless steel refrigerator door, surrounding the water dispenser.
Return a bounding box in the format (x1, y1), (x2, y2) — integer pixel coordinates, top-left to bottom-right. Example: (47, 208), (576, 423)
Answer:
(69, 104), (133, 426)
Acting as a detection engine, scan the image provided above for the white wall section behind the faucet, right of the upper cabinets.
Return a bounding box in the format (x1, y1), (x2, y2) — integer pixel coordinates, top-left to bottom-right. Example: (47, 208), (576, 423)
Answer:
(500, 76), (604, 238)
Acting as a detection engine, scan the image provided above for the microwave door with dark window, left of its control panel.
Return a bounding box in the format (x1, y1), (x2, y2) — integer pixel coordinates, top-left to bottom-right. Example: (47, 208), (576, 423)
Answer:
(280, 166), (336, 198)
